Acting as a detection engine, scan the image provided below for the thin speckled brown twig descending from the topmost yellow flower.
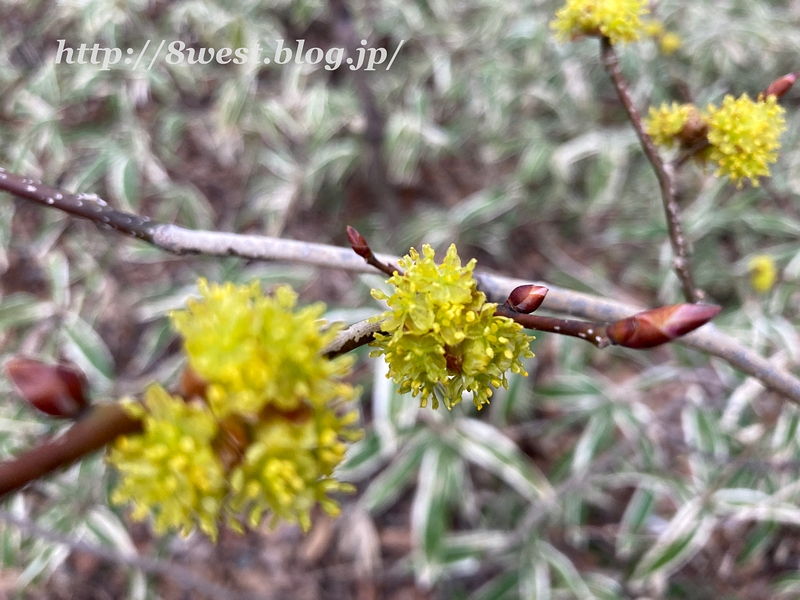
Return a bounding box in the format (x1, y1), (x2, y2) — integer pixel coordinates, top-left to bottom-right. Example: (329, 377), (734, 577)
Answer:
(601, 37), (705, 302)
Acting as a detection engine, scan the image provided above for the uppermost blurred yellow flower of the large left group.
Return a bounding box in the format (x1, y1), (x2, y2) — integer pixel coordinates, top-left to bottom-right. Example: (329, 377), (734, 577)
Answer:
(171, 280), (352, 417)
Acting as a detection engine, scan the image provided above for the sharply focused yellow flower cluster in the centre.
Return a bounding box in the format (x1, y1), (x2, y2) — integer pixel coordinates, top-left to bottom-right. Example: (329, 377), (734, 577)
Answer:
(372, 244), (533, 408)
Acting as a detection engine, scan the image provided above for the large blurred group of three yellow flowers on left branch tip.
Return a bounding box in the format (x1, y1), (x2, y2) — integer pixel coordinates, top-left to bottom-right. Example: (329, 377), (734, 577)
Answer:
(104, 280), (361, 538)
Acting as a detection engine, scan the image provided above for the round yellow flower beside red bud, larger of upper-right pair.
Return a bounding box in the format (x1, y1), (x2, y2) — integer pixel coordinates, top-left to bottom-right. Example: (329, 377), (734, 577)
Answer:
(705, 94), (786, 188)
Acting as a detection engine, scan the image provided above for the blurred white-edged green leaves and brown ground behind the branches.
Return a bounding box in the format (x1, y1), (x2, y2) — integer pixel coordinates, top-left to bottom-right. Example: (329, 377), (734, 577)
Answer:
(0, 0), (800, 600)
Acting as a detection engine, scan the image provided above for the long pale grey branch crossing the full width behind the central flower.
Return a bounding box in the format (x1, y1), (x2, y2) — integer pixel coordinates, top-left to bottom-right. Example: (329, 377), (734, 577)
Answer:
(0, 171), (800, 403)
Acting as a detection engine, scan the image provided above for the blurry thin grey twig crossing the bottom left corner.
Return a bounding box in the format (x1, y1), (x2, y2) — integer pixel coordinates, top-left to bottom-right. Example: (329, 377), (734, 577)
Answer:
(0, 510), (273, 600)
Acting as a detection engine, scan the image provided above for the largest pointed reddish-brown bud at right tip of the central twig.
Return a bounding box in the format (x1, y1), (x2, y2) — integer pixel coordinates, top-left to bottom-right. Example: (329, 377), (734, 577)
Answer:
(606, 304), (722, 349)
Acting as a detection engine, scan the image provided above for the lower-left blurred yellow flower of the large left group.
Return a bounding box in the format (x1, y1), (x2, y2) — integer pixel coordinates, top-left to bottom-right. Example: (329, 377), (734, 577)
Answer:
(108, 384), (226, 539)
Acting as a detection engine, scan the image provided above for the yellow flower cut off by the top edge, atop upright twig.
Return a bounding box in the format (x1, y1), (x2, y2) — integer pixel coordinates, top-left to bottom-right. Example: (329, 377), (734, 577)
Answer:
(550, 0), (650, 44)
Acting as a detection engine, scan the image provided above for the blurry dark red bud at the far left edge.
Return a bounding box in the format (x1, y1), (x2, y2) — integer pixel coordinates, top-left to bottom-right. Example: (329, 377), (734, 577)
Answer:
(6, 357), (89, 419)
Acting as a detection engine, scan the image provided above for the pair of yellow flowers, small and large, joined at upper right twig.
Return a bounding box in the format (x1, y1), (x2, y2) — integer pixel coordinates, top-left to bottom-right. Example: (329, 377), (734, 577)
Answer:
(645, 94), (786, 187)
